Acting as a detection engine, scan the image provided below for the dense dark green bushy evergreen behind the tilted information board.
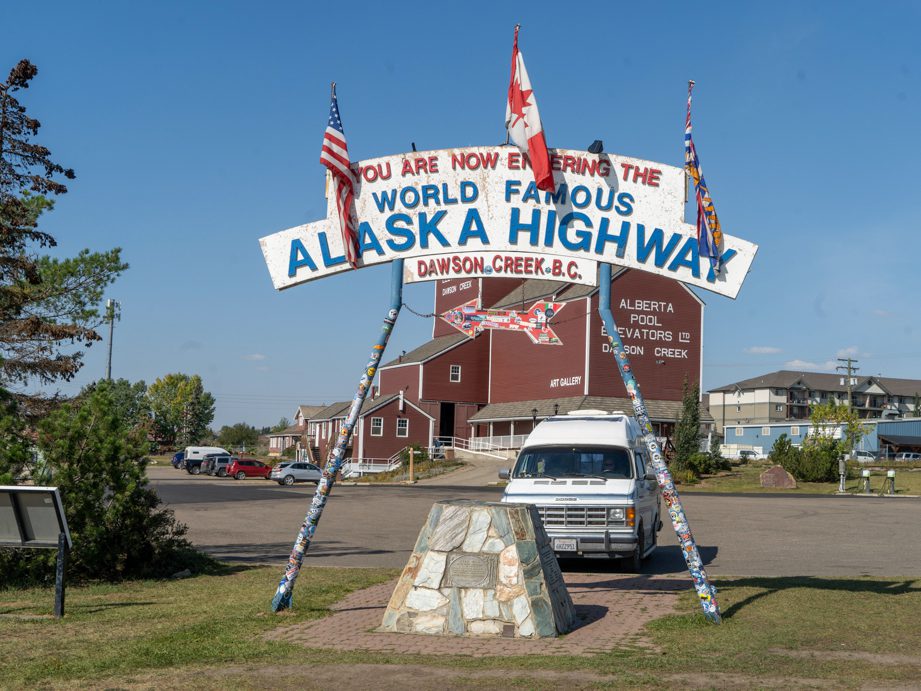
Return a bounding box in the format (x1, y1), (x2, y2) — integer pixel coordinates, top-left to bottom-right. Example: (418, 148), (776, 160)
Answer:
(0, 381), (207, 583)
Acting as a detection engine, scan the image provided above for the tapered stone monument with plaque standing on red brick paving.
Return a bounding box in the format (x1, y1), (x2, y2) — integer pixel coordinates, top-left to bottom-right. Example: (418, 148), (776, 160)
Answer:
(380, 501), (576, 638)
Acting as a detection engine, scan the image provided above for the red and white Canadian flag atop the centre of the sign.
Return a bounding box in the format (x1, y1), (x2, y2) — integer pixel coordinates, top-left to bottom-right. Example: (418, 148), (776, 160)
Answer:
(505, 26), (555, 192)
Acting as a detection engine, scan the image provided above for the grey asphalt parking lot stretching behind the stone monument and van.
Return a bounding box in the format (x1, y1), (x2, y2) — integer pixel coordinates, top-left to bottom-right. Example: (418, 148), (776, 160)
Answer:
(149, 468), (921, 577)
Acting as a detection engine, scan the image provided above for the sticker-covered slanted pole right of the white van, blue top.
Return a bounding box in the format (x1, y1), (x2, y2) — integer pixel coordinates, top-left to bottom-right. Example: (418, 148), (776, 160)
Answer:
(598, 264), (722, 624)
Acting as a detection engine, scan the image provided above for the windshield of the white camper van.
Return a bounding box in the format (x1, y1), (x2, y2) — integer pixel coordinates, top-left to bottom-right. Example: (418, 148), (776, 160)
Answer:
(512, 446), (633, 480)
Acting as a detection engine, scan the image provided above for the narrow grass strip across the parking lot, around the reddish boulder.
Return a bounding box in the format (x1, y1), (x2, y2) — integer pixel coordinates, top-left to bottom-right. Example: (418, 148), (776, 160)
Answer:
(678, 461), (921, 495)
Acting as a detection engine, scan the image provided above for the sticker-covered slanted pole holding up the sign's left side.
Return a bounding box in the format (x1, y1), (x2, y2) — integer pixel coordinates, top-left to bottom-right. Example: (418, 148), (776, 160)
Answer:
(272, 259), (403, 612)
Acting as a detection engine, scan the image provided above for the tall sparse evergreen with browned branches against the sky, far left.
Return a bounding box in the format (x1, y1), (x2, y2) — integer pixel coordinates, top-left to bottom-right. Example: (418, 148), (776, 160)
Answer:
(0, 60), (127, 400)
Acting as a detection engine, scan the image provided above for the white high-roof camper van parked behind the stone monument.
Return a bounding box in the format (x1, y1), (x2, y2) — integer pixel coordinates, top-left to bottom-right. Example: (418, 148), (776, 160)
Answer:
(502, 410), (662, 571)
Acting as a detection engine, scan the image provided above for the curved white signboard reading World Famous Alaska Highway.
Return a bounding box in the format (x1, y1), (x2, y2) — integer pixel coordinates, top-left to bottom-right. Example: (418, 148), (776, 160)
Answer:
(260, 146), (757, 298)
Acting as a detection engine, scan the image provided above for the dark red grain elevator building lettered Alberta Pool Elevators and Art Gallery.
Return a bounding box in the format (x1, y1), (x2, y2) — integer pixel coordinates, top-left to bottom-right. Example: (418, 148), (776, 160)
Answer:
(309, 270), (712, 462)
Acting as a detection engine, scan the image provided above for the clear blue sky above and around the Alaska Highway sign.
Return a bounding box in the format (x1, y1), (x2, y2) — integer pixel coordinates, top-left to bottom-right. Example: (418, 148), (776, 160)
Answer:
(0, 2), (921, 426)
